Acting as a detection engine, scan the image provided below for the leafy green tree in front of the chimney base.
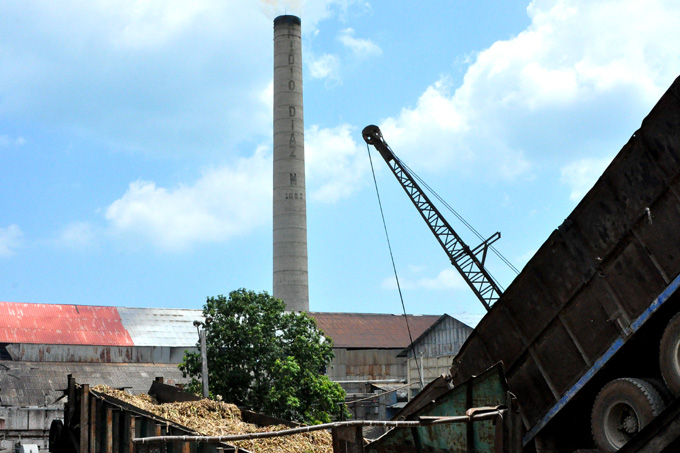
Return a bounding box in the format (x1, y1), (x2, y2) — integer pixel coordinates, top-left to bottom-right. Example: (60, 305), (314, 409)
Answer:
(179, 289), (346, 424)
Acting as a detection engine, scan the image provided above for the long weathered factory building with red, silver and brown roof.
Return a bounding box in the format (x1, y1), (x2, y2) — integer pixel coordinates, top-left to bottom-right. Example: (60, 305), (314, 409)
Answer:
(0, 302), (469, 449)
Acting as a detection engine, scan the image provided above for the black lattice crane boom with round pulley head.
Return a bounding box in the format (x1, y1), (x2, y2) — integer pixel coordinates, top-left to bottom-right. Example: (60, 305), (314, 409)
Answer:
(361, 125), (502, 310)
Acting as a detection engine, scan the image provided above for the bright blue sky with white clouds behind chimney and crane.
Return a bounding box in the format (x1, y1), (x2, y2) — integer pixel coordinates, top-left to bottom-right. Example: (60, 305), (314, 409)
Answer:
(0, 0), (680, 325)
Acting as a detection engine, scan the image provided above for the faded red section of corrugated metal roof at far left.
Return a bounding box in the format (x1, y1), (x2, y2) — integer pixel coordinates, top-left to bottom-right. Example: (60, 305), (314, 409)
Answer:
(0, 302), (133, 346)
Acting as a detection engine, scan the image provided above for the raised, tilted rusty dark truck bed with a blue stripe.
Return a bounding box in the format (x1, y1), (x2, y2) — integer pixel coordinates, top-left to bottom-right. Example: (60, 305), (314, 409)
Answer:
(451, 78), (680, 451)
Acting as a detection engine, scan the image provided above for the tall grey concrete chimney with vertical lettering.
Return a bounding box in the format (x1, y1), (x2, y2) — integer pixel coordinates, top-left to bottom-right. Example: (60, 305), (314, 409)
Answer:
(273, 15), (309, 311)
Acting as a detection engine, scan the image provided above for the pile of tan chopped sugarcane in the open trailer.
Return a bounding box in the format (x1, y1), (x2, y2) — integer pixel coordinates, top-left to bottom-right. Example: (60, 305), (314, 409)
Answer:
(93, 385), (333, 453)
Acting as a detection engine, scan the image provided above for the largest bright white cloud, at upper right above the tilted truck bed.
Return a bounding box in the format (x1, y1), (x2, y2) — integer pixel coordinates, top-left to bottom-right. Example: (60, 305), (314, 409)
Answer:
(380, 0), (680, 180)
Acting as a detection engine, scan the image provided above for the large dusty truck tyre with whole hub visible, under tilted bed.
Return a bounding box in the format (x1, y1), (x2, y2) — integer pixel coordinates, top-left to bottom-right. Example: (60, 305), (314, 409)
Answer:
(590, 378), (664, 452)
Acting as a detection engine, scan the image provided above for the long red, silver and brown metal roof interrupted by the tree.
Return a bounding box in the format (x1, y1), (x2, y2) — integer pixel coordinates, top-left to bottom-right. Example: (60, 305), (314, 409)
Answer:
(0, 302), (440, 350)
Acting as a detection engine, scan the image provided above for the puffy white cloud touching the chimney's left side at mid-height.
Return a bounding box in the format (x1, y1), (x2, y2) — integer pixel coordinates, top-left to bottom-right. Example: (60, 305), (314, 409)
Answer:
(105, 148), (271, 251)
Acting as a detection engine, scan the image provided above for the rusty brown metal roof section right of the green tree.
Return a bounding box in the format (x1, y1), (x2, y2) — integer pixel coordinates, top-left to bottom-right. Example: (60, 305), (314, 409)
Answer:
(309, 312), (440, 349)
